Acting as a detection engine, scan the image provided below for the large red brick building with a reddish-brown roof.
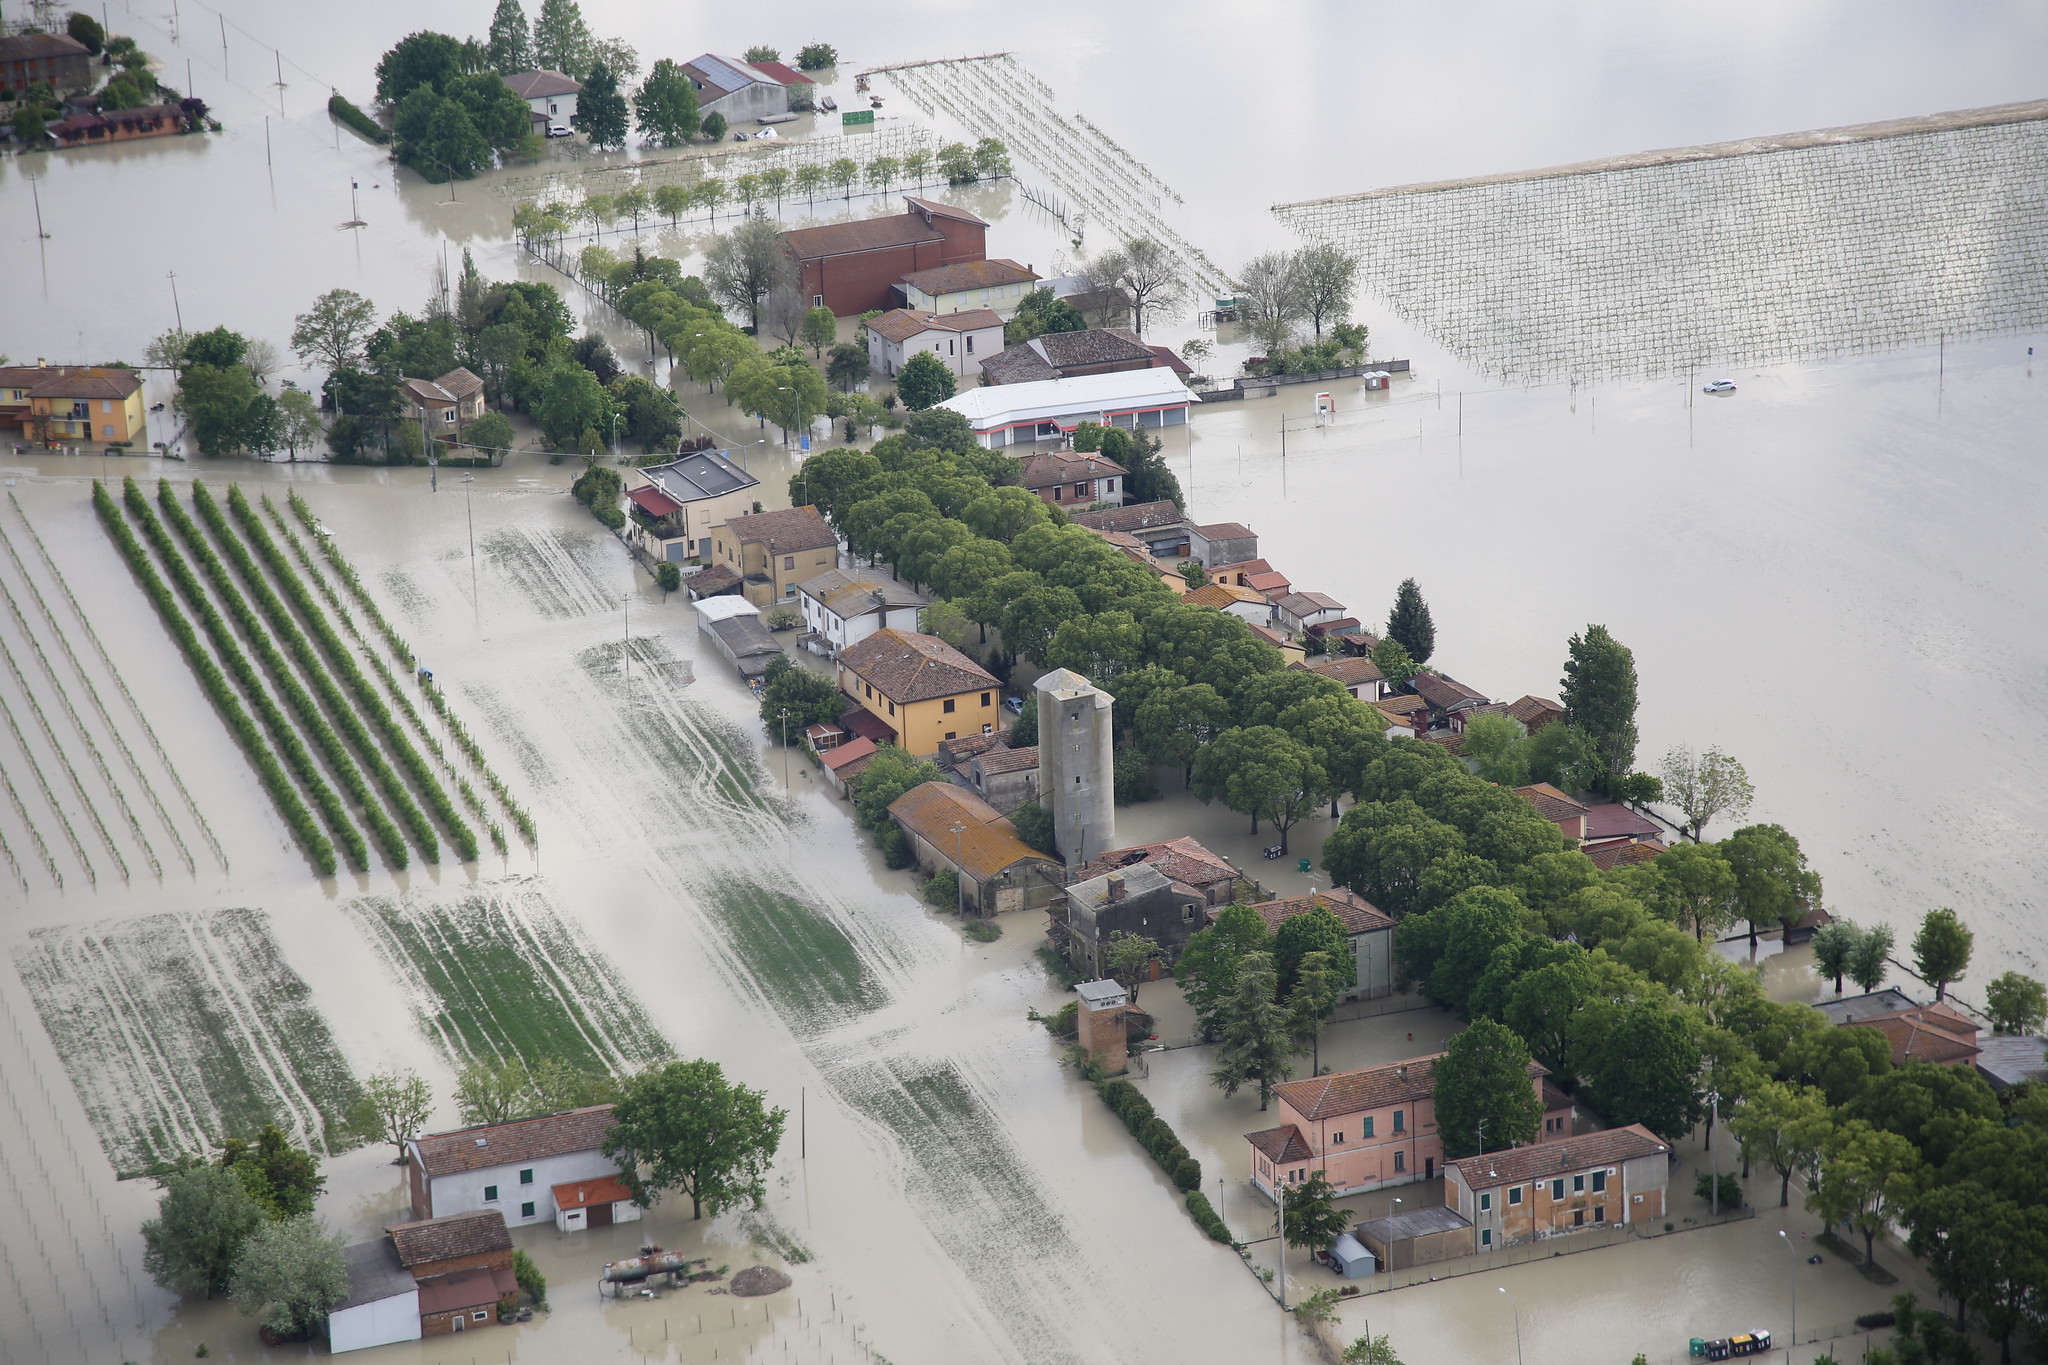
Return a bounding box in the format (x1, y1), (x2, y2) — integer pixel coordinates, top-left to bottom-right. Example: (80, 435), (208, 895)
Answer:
(782, 194), (989, 317)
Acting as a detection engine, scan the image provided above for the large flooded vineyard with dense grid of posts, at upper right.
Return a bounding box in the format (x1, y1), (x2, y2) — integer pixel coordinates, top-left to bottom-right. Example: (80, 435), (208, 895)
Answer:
(1274, 115), (2048, 383)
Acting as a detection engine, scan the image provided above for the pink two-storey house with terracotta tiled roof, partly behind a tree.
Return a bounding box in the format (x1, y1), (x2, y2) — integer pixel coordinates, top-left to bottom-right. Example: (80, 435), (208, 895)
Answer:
(1245, 1052), (1571, 1195)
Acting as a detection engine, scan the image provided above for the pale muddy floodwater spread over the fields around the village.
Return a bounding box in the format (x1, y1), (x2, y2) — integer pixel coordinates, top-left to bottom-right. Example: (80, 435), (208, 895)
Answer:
(0, 0), (2048, 1365)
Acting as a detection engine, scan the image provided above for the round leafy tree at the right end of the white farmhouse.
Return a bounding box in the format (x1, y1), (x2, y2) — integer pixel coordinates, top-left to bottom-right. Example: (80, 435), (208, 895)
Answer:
(600, 1060), (788, 1218)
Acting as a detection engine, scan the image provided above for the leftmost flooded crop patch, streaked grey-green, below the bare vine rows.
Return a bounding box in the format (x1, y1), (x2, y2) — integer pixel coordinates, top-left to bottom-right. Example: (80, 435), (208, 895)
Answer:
(14, 909), (360, 1175)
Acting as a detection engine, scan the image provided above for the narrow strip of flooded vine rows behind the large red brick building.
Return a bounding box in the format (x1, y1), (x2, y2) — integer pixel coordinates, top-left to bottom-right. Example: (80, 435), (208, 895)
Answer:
(881, 53), (1231, 295)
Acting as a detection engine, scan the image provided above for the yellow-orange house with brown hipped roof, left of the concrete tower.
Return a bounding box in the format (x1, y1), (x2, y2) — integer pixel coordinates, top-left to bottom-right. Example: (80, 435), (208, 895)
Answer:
(840, 628), (1004, 757)
